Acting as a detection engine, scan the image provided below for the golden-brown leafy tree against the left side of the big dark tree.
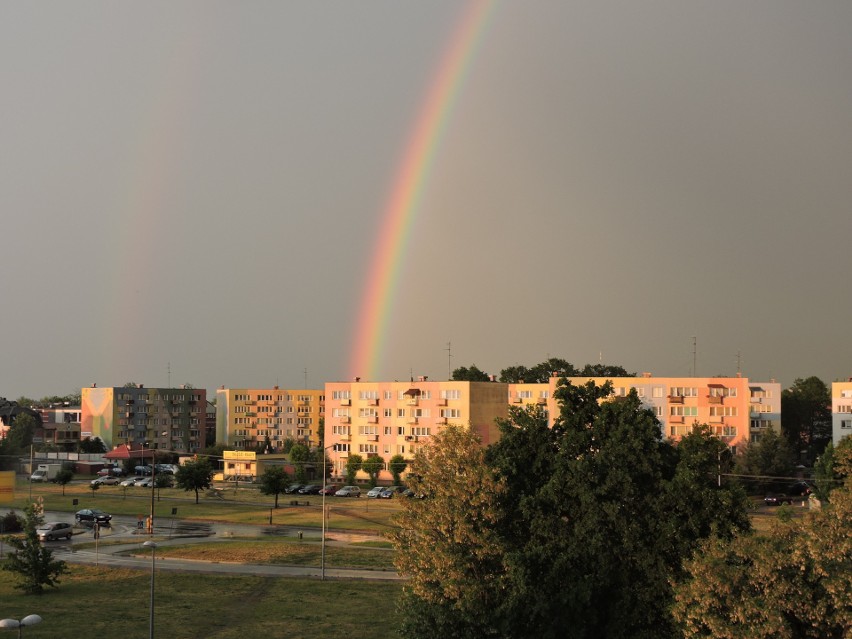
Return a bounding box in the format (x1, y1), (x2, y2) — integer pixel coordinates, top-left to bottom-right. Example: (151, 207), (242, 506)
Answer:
(390, 425), (510, 639)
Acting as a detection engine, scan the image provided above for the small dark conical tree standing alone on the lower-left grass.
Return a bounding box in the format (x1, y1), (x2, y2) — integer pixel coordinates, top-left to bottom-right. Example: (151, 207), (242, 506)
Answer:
(0, 502), (66, 595)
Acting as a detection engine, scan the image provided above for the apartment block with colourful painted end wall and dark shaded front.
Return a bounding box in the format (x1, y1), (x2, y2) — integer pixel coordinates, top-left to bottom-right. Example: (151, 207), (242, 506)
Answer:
(81, 385), (207, 453)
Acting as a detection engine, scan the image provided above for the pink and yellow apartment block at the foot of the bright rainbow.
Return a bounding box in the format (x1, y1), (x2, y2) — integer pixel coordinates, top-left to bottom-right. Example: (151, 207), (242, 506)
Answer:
(323, 378), (508, 479)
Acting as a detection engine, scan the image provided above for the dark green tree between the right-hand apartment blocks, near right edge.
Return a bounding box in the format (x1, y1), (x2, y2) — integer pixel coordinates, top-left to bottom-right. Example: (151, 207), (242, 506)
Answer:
(781, 376), (831, 461)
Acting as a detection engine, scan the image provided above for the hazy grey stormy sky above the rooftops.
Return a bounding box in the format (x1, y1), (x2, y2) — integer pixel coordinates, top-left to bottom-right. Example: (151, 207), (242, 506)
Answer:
(0, 0), (852, 399)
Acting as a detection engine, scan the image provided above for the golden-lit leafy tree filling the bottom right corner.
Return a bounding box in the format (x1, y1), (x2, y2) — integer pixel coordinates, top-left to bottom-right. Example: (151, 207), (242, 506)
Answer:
(673, 440), (852, 639)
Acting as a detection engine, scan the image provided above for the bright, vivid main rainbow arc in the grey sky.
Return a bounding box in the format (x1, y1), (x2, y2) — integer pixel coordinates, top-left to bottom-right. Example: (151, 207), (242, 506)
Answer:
(349, 0), (496, 379)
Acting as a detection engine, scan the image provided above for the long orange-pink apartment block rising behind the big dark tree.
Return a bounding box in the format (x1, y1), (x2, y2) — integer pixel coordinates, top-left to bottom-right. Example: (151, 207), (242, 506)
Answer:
(508, 373), (781, 452)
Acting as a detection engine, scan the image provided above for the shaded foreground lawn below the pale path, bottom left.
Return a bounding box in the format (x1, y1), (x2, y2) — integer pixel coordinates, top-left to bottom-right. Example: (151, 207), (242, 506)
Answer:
(0, 565), (402, 639)
